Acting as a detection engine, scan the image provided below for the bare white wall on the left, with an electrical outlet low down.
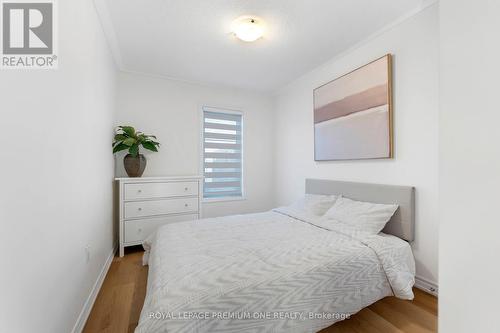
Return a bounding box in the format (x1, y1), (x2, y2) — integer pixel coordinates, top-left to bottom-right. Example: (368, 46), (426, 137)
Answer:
(0, 0), (115, 333)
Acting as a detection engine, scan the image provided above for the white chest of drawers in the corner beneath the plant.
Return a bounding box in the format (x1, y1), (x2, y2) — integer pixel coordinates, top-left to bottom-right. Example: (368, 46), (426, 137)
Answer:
(116, 176), (202, 257)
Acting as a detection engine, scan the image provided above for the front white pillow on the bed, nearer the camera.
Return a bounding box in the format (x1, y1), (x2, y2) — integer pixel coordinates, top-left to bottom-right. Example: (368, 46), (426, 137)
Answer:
(323, 197), (398, 234)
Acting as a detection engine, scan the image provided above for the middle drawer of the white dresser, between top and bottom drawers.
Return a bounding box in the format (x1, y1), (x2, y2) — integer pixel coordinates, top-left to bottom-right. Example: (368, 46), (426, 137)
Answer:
(124, 198), (198, 219)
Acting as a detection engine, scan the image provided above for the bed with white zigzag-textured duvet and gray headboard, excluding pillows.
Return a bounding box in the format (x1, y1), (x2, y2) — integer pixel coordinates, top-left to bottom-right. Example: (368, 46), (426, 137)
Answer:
(136, 179), (415, 333)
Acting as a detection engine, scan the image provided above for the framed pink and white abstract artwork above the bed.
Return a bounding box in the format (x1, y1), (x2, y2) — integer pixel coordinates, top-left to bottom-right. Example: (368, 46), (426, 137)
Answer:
(314, 54), (393, 161)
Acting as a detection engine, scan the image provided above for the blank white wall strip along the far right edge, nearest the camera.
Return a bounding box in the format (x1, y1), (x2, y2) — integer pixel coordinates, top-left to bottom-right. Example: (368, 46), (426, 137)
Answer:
(439, 0), (500, 333)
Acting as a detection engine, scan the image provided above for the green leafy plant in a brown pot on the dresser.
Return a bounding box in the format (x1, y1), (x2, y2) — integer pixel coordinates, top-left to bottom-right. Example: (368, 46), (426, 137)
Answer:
(113, 126), (160, 177)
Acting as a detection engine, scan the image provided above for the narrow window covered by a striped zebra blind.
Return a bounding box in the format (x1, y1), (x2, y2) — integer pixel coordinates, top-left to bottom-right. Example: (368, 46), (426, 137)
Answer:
(203, 107), (243, 199)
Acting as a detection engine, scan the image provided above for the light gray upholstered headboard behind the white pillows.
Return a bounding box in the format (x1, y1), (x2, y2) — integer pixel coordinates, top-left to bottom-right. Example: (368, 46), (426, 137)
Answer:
(306, 179), (415, 241)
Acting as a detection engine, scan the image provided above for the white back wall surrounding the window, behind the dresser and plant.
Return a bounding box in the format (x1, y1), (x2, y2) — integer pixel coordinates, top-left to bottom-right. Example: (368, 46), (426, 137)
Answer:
(116, 73), (274, 217)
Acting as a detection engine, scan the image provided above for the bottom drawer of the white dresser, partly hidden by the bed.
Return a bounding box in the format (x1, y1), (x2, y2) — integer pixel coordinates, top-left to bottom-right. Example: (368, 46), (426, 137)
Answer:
(124, 214), (198, 243)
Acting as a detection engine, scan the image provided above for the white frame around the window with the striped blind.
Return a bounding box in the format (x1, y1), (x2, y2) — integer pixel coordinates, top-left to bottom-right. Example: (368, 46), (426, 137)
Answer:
(199, 104), (246, 203)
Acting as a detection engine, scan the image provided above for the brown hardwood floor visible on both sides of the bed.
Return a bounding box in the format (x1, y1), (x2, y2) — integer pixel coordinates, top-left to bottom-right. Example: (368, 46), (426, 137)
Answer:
(83, 247), (437, 333)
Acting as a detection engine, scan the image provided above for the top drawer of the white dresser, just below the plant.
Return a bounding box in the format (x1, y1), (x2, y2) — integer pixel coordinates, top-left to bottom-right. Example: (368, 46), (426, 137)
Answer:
(124, 181), (198, 200)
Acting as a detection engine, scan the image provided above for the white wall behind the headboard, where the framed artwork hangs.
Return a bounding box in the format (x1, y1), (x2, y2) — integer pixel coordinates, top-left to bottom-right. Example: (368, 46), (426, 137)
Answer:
(275, 5), (438, 282)
